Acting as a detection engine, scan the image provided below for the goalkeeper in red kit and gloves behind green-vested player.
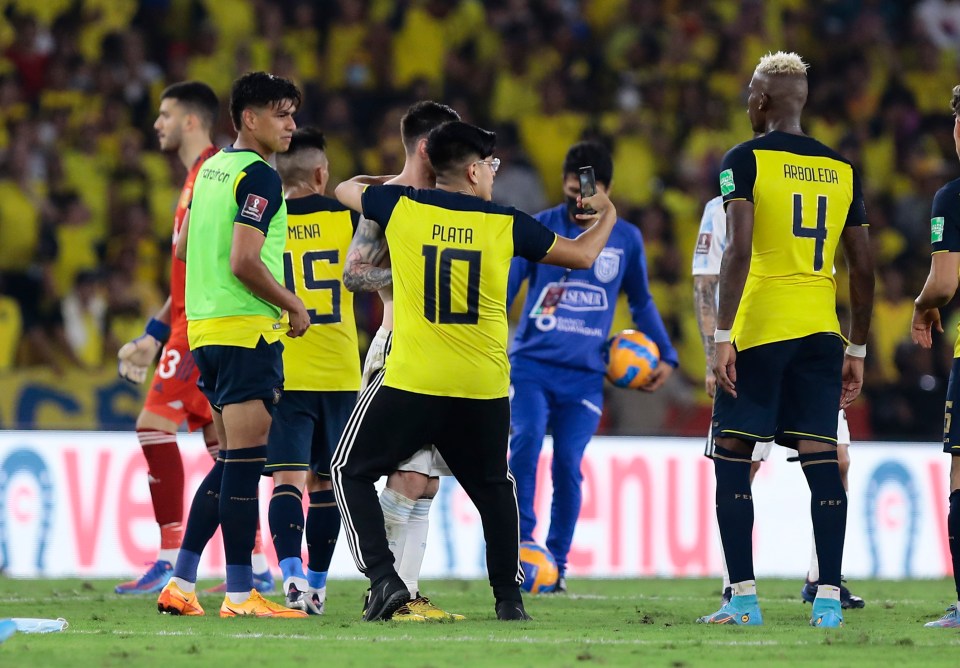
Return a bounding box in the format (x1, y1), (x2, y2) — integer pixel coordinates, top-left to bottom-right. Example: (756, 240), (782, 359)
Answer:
(114, 81), (273, 594)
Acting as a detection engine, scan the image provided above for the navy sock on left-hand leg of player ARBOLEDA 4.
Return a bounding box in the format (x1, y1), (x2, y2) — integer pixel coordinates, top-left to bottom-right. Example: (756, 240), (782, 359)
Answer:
(713, 445), (755, 582)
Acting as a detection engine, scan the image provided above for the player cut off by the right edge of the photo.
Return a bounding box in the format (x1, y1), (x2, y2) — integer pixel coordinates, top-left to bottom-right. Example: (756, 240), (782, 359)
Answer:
(912, 86), (960, 629)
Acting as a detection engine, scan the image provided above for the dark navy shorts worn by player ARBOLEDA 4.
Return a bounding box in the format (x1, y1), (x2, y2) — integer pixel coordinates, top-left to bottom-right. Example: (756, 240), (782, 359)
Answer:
(713, 333), (843, 447)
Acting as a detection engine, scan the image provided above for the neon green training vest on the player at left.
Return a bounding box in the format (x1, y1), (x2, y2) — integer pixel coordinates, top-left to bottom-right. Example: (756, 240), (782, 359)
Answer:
(186, 150), (287, 320)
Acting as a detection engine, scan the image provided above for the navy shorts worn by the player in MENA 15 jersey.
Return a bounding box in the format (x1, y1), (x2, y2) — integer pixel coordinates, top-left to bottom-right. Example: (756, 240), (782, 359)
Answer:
(263, 390), (357, 478)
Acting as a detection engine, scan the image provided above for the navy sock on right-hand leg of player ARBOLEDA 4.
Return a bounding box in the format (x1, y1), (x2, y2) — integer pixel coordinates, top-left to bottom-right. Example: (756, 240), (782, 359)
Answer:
(800, 450), (847, 587)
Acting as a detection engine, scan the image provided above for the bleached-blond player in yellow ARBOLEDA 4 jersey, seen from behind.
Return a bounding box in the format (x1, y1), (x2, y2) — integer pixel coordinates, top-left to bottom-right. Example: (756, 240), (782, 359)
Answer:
(700, 52), (874, 627)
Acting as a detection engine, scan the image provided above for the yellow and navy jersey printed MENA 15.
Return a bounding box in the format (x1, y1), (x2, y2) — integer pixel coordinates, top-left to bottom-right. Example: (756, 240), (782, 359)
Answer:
(283, 195), (360, 392)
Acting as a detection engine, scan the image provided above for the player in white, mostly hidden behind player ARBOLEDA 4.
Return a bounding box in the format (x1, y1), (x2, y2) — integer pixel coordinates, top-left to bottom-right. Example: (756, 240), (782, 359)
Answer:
(693, 196), (864, 609)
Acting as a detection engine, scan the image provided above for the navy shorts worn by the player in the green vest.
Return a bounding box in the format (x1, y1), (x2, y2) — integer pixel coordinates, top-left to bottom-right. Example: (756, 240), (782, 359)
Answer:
(193, 337), (283, 413)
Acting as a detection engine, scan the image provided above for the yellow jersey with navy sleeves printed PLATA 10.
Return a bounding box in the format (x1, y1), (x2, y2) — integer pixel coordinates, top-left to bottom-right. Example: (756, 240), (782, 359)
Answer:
(362, 185), (557, 399)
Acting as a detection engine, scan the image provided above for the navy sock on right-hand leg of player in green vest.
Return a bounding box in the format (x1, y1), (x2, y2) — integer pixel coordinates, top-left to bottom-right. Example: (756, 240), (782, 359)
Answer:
(220, 445), (267, 592)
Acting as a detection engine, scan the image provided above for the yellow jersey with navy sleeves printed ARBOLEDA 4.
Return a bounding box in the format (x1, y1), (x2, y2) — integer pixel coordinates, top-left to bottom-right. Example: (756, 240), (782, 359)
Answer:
(720, 132), (866, 350)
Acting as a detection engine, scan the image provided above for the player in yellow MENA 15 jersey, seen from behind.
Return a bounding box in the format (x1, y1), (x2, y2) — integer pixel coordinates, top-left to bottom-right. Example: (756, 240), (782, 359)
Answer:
(264, 127), (360, 615)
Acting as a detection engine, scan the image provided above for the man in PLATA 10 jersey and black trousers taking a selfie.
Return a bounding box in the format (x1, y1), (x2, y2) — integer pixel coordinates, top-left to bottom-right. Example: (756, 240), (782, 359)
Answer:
(331, 121), (616, 621)
